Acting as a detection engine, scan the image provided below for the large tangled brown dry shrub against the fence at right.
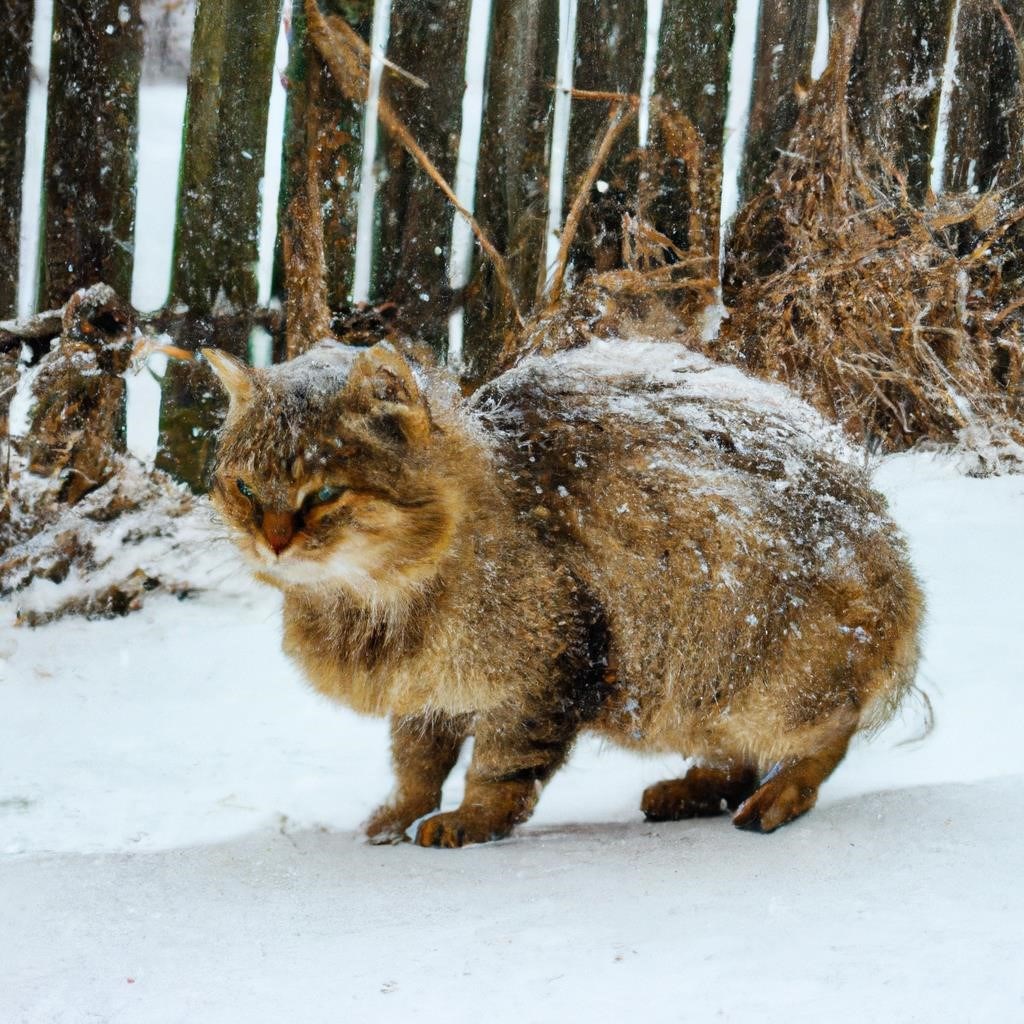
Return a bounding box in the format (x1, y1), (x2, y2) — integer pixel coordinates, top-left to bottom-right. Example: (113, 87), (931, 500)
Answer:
(720, 12), (1024, 449)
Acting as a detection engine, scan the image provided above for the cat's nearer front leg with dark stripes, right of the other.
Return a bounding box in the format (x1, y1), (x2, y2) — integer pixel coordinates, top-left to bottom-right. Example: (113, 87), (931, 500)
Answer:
(416, 712), (579, 848)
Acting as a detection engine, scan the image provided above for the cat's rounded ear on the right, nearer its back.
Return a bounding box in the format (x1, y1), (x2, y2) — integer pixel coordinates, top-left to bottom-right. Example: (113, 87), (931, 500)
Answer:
(345, 343), (432, 442)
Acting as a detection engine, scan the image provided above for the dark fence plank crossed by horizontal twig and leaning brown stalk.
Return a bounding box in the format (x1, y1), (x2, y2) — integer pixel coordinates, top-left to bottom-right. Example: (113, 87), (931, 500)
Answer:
(565, 0), (643, 276)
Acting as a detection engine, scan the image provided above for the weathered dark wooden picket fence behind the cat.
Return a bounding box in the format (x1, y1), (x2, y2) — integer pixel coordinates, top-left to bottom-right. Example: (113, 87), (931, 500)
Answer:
(0, 0), (1024, 485)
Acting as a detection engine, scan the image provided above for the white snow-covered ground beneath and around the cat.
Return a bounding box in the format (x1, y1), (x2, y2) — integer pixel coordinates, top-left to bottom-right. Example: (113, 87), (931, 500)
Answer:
(0, 455), (1024, 1024)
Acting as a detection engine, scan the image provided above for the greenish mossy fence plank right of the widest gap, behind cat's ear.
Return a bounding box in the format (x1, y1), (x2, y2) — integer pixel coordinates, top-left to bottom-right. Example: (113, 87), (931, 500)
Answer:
(157, 0), (281, 489)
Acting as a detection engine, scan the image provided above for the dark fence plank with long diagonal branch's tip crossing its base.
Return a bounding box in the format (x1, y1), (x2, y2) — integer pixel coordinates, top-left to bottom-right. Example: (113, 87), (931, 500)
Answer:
(465, 0), (558, 376)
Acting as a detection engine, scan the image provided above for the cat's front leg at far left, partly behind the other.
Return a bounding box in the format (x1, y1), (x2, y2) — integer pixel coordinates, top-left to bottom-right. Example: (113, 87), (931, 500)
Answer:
(364, 715), (469, 845)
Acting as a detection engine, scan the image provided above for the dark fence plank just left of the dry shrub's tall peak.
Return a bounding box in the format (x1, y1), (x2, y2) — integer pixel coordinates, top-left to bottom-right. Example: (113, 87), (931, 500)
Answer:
(739, 0), (818, 203)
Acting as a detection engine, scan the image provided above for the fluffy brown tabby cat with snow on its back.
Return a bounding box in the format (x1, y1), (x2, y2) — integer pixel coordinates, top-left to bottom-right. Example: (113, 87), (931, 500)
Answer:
(207, 342), (922, 847)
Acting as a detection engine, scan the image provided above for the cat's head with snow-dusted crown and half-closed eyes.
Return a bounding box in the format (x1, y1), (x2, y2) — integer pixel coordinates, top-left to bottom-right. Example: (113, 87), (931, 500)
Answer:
(204, 344), (461, 601)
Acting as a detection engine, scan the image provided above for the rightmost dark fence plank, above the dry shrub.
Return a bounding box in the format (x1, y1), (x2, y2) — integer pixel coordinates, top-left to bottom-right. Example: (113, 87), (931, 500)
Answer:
(945, 0), (1024, 191)
